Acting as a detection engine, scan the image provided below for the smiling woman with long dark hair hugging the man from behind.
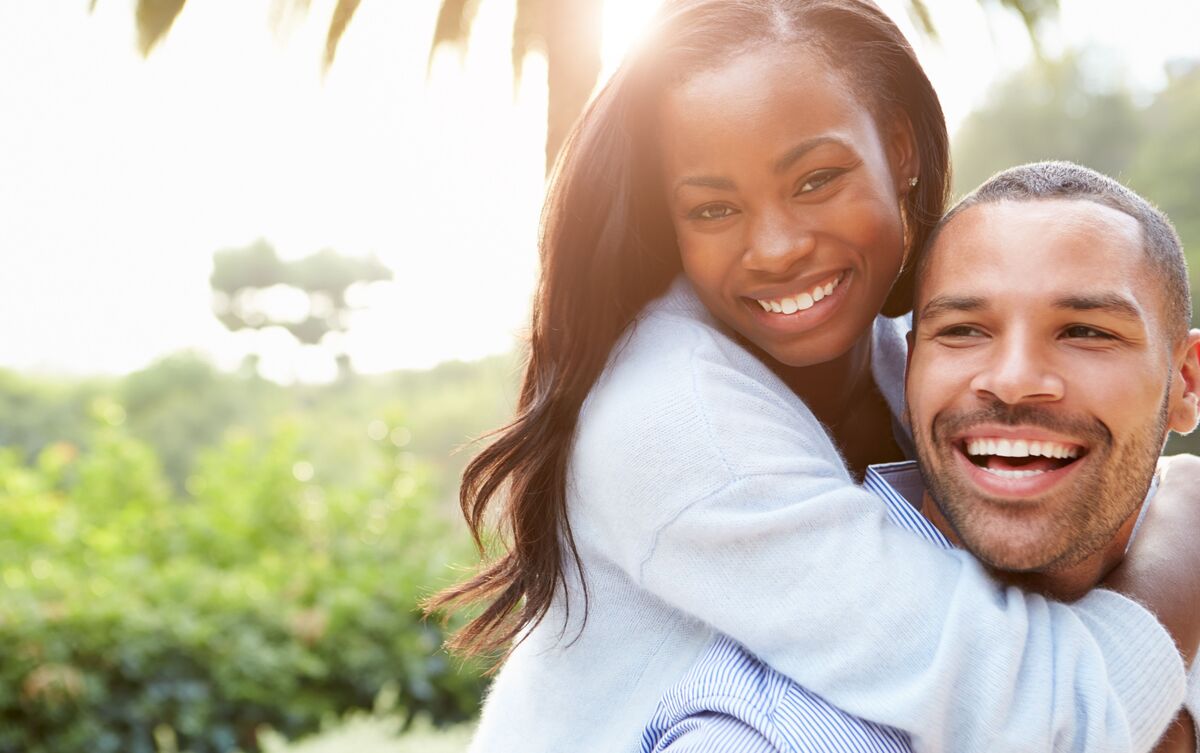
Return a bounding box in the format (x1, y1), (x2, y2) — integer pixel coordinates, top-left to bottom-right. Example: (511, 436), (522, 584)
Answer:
(436, 0), (1196, 753)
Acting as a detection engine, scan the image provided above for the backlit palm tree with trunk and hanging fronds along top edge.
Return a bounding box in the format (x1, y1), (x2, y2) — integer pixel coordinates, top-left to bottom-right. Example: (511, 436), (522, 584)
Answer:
(114, 0), (1058, 171)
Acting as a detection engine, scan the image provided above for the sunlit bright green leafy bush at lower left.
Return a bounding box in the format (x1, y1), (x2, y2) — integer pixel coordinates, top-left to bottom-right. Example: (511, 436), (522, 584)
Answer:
(0, 414), (481, 753)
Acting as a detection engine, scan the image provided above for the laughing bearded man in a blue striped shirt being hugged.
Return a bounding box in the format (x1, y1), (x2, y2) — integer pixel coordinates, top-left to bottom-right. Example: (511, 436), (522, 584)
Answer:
(643, 163), (1200, 753)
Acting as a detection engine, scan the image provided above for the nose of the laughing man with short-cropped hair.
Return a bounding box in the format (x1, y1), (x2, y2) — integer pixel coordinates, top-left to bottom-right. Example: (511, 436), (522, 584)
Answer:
(971, 333), (1066, 405)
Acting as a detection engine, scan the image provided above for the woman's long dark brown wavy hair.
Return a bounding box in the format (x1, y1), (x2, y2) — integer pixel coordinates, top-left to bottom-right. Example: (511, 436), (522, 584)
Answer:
(426, 0), (949, 655)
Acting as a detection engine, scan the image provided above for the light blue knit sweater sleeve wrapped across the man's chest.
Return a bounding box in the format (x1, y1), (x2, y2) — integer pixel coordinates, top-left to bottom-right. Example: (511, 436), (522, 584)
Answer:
(571, 321), (1184, 752)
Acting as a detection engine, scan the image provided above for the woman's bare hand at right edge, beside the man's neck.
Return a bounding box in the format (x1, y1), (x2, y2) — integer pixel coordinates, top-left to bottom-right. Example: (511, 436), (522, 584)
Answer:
(1100, 454), (1200, 665)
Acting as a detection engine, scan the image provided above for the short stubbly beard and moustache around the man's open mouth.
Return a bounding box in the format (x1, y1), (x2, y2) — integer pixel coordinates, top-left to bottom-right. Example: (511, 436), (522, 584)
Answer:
(913, 390), (1170, 572)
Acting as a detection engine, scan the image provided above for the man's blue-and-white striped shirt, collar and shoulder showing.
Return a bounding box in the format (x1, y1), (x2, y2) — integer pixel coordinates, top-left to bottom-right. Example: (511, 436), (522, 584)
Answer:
(641, 462), (1158, 753)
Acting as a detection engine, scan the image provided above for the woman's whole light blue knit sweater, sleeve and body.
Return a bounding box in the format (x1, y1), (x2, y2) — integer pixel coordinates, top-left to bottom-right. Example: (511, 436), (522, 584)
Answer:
(472, 279), (1184, 753)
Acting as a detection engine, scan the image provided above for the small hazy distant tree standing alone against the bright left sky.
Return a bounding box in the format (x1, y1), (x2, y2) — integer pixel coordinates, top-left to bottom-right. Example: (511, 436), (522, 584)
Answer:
(209, 239), (392, 374)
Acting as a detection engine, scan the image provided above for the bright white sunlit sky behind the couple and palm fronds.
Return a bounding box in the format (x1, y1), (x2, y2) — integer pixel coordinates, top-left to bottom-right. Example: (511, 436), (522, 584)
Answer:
(0, 0), (1200, 381)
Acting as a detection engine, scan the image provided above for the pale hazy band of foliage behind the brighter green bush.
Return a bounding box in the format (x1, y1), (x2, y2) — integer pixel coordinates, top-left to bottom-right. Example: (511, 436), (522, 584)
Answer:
(0, 353), (517, 505)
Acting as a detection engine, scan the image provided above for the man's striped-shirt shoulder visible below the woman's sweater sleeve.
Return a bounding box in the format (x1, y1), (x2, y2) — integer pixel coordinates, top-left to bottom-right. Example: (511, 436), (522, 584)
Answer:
(642, 635), (911, 753)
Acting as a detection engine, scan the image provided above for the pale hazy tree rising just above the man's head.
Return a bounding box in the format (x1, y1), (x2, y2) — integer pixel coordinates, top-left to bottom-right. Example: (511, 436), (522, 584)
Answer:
(954, 53), (1144, 195)
